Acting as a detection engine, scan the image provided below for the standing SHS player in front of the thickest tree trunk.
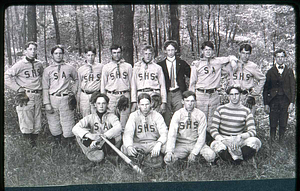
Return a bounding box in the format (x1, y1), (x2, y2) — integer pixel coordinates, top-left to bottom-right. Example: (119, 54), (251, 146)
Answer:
(101, 45), (132, 130)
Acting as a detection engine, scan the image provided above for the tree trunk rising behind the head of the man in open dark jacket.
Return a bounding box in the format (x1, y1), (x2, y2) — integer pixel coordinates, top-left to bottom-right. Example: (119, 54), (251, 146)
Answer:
(170, 4), (180, 48)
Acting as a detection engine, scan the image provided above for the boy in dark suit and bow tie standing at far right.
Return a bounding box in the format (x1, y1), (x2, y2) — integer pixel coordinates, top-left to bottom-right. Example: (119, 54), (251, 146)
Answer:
(263, 49), (296, 144)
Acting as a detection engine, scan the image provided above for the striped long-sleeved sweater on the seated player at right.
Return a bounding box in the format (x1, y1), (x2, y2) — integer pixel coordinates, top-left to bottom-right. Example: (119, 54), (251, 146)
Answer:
(210, 103), (256, 139)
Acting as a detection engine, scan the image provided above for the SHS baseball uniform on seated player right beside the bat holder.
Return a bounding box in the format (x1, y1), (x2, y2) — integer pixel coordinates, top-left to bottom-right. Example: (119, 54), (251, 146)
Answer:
(122, 110), (168, 154)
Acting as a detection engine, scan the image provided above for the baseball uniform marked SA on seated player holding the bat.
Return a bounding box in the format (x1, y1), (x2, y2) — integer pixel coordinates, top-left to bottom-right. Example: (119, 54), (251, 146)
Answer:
(72, 113), (122, 162)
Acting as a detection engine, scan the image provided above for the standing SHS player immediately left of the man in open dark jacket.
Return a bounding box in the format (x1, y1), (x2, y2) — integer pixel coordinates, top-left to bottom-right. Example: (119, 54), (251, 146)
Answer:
(131, 45), (167, 113)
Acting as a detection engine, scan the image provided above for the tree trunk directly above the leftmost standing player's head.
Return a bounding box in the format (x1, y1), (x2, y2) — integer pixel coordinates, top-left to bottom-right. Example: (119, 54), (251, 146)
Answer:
(27, 5), (37, 42)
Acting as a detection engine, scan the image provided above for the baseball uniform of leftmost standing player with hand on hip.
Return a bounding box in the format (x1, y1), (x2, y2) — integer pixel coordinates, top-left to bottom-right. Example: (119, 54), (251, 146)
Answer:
(5, 57), (43, 134)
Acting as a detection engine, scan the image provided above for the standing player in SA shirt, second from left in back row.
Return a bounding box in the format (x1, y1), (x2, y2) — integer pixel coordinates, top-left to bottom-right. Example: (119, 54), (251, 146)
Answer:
(43, 45), (78, 143)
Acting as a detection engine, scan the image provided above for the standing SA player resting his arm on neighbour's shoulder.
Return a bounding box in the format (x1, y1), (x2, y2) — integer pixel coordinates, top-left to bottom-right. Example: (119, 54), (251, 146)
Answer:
(189, 41), (237, 142)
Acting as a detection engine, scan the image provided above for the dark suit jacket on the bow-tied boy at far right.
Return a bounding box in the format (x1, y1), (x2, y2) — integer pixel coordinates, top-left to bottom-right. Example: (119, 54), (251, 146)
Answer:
(263, 66), (296, 105)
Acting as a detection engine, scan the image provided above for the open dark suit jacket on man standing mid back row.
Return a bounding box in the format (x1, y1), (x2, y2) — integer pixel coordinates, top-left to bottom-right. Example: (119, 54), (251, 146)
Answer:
(157, 57), (191, 92)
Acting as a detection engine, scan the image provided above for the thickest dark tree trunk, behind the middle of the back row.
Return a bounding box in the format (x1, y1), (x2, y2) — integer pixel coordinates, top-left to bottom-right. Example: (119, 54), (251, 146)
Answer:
(112, 5), (134, 65)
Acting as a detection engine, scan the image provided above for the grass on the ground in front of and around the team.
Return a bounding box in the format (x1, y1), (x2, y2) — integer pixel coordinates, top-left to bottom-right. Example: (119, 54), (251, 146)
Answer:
(4, 90), (296, 187)
